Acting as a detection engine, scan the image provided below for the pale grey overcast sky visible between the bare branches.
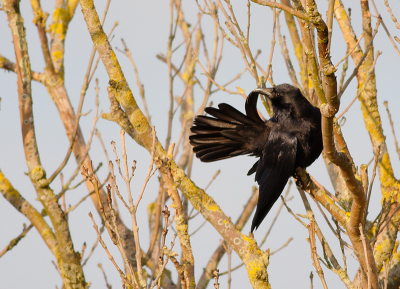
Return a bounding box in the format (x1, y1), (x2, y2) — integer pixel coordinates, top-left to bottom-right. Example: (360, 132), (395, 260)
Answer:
(0, 0), (400, 289)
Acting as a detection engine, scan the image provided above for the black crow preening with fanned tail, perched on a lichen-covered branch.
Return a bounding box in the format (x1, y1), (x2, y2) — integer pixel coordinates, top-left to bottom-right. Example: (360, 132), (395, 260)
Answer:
(189, 84), (323, 232)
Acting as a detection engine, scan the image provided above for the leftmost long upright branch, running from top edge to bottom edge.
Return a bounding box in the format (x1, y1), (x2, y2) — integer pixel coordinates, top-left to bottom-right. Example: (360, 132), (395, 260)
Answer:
(3, 0), (86, 289)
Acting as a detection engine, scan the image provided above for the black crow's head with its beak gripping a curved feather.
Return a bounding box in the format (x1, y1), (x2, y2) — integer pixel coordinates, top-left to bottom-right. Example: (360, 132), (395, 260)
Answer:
(253, 83), (311, 115)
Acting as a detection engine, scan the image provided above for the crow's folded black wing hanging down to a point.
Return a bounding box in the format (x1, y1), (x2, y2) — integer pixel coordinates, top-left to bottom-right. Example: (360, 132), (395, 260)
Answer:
(251, 124), (297, 232)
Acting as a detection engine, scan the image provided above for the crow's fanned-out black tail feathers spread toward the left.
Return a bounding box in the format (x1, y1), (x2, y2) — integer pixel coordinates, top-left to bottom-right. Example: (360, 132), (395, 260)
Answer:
(189, 103), (263, 162)
